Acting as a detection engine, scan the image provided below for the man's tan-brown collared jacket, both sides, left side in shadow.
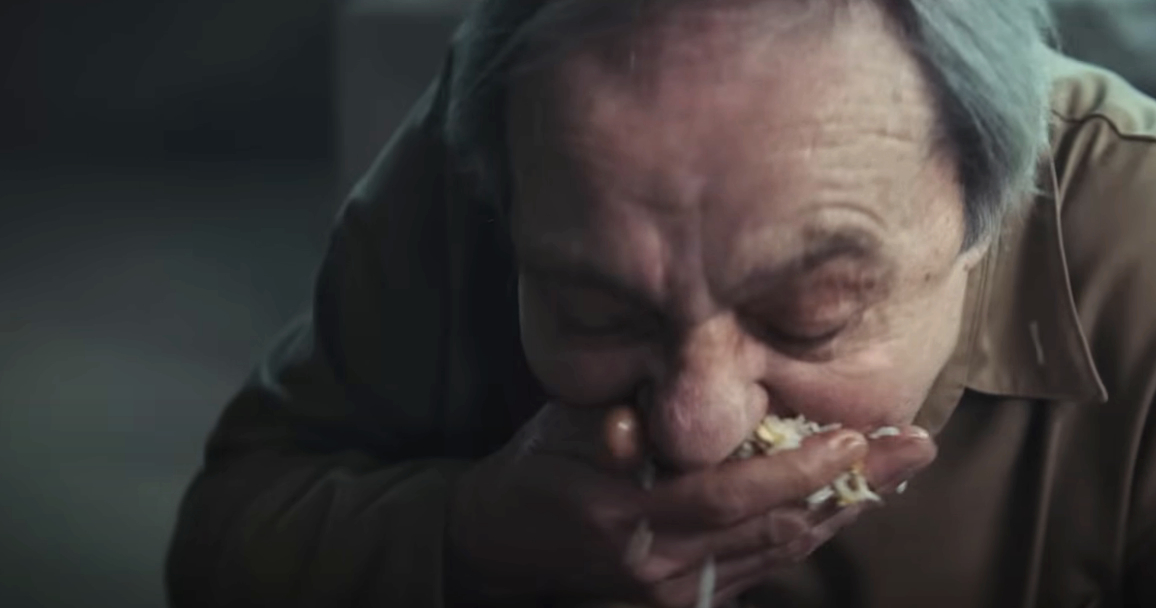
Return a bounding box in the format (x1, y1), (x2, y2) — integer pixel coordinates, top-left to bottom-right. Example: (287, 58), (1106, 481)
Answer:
(168, 52), (1156, 608)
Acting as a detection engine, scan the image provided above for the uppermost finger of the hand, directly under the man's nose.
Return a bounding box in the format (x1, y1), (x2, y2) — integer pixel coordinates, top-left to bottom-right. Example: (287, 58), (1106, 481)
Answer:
(645, 430), (867, 531)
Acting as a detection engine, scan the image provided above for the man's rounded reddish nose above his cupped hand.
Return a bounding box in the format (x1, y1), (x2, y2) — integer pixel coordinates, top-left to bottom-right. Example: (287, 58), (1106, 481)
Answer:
(643, 318), (768, 470)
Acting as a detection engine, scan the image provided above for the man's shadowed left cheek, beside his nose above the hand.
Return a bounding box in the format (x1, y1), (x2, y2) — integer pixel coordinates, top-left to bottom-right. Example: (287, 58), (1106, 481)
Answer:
(518, 283), (645, 406)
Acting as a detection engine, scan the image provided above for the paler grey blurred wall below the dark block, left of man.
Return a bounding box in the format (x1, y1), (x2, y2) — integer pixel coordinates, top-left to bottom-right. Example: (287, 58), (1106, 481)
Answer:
(0, 160), (332, 608)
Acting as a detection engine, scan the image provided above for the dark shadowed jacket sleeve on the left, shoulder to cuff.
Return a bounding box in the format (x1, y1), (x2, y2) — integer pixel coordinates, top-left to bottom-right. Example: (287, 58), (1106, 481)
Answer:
(165, 65), (492, 608)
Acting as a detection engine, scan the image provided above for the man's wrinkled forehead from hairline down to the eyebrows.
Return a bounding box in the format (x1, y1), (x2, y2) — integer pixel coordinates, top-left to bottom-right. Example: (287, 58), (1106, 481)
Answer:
(507, 2), (962, 280)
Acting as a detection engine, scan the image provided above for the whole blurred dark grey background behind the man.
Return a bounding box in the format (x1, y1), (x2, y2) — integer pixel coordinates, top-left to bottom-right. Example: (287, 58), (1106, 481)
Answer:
(0, 0), (1156, 608)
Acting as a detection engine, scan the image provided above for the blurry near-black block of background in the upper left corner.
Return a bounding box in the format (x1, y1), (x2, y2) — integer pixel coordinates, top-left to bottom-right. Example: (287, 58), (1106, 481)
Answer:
(0, 0), (334, 160)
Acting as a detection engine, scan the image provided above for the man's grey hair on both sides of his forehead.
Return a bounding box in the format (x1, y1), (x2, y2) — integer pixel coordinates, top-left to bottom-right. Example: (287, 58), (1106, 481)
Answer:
(445, 0), (1054, 250)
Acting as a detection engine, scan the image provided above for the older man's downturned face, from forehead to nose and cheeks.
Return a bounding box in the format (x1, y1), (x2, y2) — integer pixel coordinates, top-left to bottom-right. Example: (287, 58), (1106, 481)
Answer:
(509, 5), (977, 468)
